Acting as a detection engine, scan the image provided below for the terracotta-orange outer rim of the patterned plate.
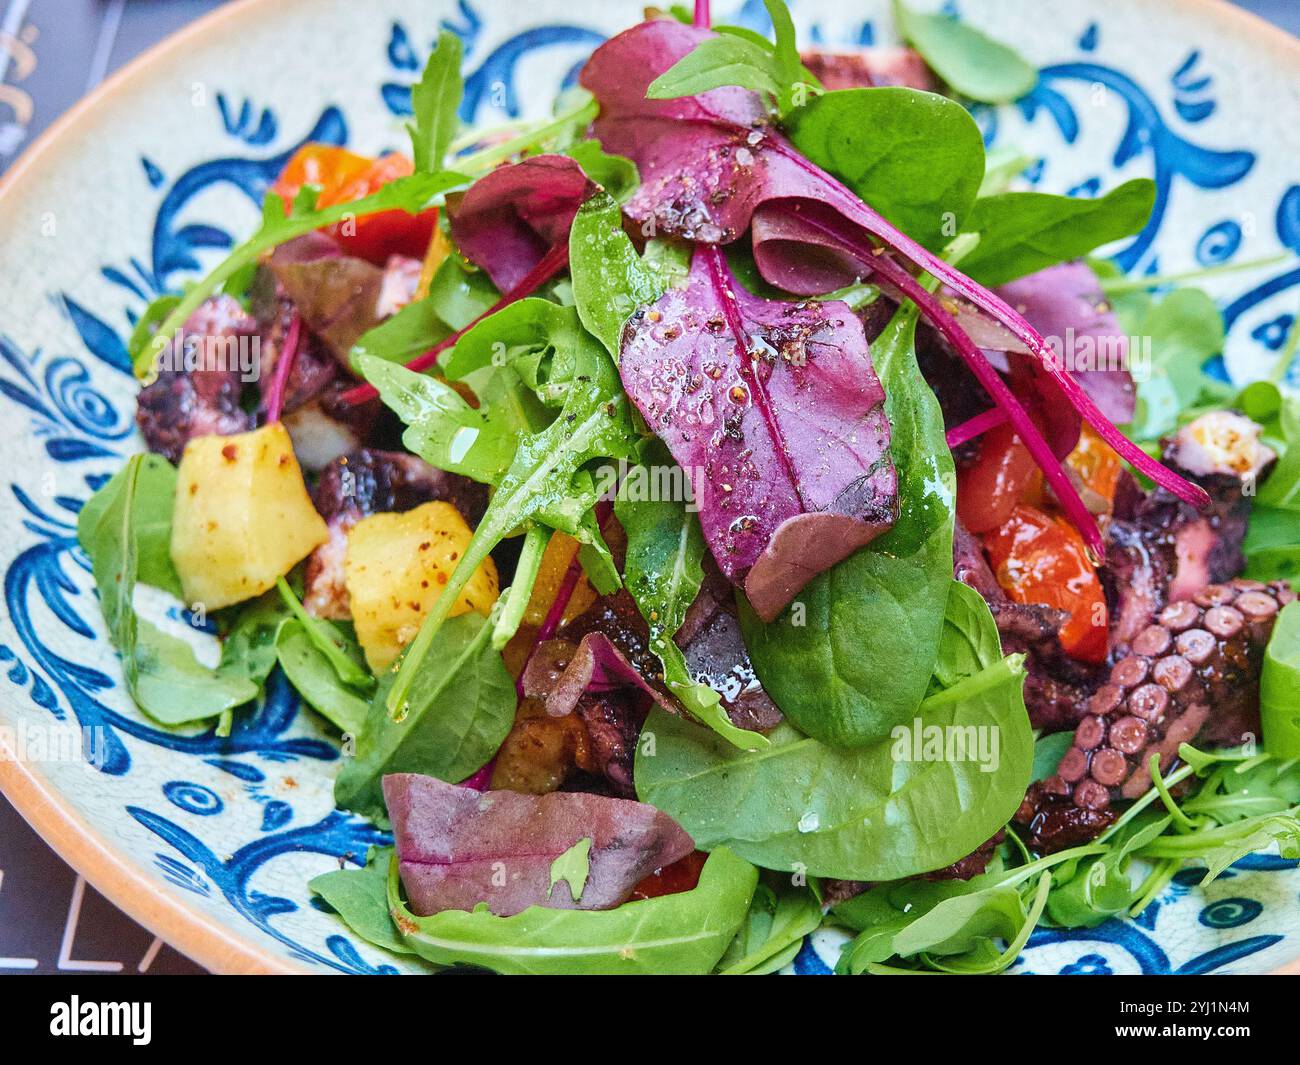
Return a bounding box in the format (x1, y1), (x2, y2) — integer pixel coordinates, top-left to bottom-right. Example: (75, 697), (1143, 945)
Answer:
(0, 0), (1300, 975)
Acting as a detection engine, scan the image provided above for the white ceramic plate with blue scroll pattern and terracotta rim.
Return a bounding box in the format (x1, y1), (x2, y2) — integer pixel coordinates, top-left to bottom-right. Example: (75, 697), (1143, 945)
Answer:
(0, 0), (1300, 973)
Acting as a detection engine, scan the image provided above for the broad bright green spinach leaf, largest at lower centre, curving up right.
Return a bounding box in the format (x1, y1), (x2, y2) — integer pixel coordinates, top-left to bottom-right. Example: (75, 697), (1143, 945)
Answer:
(636, 657), (1034, 880)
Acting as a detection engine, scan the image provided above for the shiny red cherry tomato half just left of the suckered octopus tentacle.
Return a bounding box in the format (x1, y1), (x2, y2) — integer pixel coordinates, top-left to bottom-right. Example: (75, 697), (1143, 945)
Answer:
(984, 505), (1109, 662)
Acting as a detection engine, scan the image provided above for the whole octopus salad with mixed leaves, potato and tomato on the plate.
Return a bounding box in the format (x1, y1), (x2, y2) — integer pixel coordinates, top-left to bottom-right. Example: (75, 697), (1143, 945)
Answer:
(78, 0), (1300, 974)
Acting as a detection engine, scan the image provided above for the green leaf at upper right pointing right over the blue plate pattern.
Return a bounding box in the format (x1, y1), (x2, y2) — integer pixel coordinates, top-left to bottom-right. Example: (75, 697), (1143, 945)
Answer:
(962, 178), (1156, 287)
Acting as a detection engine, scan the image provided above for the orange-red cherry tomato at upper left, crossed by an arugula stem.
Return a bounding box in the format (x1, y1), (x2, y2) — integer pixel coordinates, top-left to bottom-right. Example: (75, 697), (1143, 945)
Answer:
(270, 144), (438, 267)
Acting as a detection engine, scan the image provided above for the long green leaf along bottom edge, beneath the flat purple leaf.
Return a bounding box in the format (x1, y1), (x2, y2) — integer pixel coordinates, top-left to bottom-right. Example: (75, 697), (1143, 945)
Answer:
(389, 848), (758, 975)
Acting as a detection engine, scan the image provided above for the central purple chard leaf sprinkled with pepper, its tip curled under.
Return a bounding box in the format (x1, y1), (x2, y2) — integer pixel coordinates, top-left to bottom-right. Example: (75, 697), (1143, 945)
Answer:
(619, 246), (897, 620)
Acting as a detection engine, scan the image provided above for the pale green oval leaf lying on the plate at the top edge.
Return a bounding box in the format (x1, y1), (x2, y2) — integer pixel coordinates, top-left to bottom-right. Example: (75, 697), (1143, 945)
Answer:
(893, 0), (1039, 104)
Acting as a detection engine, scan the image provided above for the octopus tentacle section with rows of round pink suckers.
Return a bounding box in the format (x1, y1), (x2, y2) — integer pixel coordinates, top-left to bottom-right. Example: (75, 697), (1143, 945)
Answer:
(1015, 580), (1295, 852)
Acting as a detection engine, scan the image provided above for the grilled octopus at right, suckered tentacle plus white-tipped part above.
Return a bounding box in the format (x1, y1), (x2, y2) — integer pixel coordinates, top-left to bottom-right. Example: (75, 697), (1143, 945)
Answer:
(1015, 414), (1295, 853)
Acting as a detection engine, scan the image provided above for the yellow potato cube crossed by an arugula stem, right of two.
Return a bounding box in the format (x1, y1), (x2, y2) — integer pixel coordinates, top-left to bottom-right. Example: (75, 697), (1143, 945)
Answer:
(343, 502), (498, 671)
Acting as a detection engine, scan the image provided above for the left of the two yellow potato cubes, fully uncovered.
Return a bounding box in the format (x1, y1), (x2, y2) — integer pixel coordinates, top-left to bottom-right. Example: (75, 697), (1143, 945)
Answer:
(172, 421), (329, 610)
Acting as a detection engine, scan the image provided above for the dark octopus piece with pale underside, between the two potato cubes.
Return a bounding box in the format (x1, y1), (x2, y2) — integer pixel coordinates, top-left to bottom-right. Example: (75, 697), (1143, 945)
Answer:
(303, 447), (488, 619)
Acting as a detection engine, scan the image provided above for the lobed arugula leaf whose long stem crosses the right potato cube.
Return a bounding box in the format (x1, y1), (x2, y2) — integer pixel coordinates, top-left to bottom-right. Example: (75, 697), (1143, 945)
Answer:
(387, 312), (637, 714)
